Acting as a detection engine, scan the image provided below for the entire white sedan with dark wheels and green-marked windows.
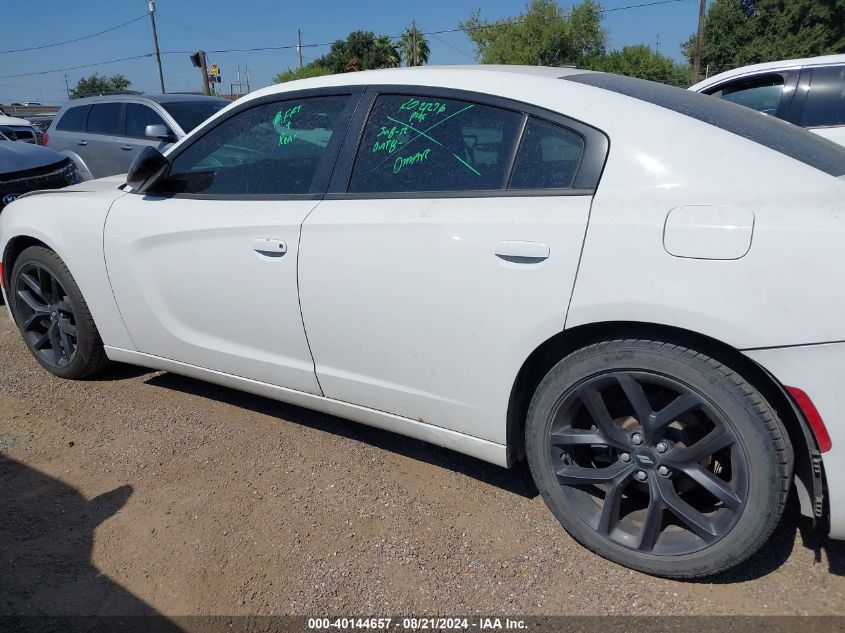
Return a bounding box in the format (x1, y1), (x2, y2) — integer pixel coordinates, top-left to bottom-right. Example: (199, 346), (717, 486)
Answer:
(0, 66), (845, 577)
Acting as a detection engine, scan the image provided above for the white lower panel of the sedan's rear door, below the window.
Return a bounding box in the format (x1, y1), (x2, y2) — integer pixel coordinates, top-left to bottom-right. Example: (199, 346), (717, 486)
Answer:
(300, 196), (591, 444)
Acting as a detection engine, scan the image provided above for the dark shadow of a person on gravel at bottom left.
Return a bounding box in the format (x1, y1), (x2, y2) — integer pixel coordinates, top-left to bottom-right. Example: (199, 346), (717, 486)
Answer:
(0, 453), (181, 633)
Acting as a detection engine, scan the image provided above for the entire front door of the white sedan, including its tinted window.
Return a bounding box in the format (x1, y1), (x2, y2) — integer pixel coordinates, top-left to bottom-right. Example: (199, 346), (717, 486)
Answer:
(105, 93), (356, 393)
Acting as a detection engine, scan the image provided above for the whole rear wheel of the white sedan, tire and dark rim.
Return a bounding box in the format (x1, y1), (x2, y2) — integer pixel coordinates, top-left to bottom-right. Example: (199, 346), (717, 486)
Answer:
(525, 340), (793, 578)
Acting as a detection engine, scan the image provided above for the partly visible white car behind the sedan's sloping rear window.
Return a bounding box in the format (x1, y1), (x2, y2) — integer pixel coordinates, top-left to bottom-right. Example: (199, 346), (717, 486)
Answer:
(690, 55), (845, 145)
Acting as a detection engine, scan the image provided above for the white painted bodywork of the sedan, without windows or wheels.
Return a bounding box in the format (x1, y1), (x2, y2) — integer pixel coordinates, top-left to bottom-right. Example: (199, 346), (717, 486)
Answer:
(0, 67), (845, 537)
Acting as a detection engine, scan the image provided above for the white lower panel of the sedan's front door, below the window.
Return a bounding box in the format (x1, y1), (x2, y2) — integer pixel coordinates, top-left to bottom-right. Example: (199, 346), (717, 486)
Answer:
(99, 194), (320, 394)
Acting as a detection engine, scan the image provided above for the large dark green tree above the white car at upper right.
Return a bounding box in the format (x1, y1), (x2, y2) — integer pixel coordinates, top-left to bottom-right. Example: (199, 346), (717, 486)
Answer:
(683, 0), (845, 74)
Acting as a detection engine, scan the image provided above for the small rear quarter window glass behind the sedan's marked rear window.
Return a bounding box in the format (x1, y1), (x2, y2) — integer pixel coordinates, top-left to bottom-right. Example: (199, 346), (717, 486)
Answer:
(509, 117), (584, 189)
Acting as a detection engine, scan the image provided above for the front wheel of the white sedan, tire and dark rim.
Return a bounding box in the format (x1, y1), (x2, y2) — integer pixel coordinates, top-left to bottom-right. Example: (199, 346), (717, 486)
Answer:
(8, 246), (109, 379)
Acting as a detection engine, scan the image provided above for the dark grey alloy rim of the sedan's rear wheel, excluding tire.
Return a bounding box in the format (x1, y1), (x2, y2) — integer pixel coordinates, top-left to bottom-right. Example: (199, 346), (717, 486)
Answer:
(548, 370), (749, 555)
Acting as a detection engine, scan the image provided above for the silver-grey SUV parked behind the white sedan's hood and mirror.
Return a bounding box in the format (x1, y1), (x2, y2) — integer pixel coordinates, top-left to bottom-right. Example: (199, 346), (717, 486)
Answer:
(46, 94), (230, 180)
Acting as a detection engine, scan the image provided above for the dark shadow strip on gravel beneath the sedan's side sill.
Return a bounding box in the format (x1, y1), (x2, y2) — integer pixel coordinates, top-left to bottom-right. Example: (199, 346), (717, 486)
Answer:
(146, 373), (539, 499)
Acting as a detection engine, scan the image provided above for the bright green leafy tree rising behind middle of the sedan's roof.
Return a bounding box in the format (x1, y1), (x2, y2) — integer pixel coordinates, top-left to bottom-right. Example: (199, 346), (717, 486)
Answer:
(460, 0), (607, 66)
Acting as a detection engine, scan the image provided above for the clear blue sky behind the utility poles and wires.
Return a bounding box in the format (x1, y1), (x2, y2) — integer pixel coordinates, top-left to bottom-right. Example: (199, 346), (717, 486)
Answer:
(0, 0), (698, 103)
